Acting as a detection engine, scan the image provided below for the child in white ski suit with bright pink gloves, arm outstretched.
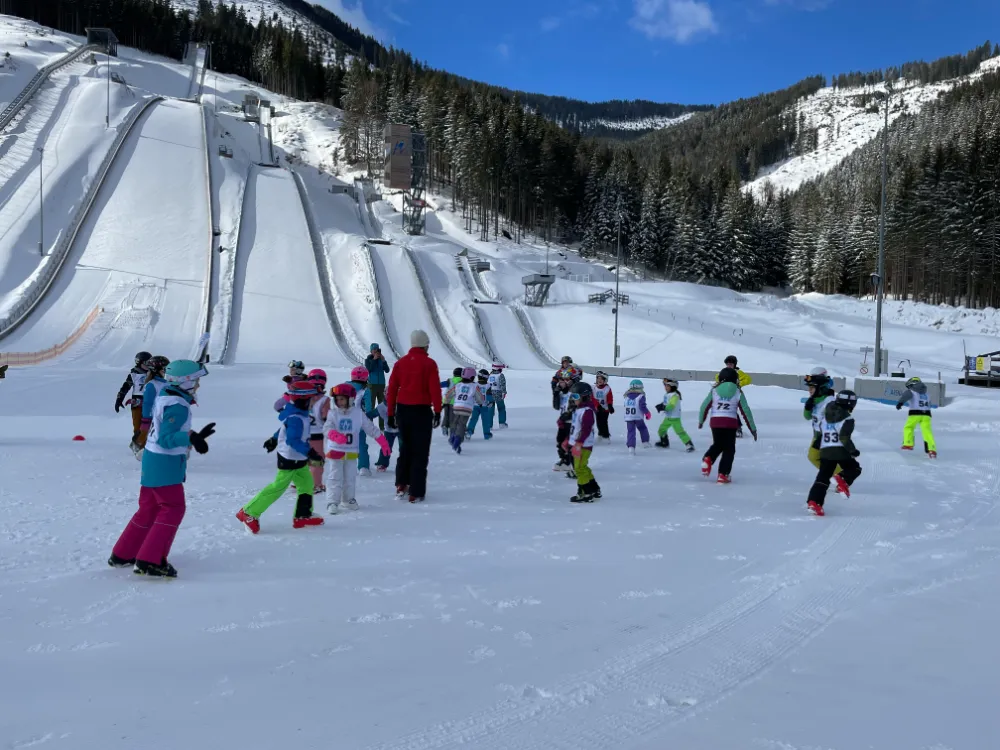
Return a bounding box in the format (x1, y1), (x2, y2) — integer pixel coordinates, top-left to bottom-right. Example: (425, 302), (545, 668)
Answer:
(323, 383), (392, 513)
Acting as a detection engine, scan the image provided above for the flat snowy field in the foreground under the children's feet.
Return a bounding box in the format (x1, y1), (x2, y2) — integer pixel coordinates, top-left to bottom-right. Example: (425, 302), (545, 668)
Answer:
(0, 362), (1000, 750)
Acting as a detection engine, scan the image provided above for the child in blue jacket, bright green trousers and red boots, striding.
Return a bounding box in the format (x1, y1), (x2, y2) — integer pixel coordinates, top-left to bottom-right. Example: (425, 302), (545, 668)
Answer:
(236, 380), (323, 534)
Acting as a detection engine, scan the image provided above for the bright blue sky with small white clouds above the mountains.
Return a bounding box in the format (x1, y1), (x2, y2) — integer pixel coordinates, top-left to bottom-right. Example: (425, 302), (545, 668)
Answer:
(314, 0), (1000, 104)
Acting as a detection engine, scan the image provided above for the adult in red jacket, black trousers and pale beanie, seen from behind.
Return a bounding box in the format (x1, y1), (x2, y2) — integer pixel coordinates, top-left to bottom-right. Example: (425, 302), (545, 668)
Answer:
(385, 330), (441, 503)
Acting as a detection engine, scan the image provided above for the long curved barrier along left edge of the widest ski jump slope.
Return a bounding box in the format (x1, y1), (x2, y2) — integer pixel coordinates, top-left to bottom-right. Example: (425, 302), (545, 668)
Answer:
(0, 96), (164, 340)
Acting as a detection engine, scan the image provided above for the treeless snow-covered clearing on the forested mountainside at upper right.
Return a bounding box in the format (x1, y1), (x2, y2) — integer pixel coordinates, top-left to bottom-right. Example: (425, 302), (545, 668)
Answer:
(744, 57), (1000, 195)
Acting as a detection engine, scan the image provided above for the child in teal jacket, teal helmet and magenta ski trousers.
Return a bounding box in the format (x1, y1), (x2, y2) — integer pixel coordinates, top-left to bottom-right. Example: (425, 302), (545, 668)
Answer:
(108, 359), (215, 578)
